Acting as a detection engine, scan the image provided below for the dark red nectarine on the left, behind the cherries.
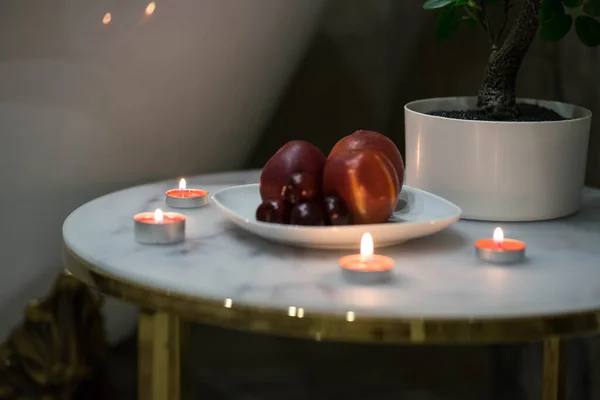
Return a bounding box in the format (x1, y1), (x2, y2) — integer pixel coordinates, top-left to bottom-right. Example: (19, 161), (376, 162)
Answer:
(259, 140), (326, 201)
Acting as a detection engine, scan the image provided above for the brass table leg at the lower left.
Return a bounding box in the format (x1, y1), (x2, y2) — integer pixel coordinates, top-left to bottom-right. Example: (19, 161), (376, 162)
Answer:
(138, 311), (187, 400)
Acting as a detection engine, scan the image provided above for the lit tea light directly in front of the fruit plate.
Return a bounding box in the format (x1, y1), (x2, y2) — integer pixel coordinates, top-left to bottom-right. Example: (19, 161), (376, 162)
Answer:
(339, 232), (394, 283)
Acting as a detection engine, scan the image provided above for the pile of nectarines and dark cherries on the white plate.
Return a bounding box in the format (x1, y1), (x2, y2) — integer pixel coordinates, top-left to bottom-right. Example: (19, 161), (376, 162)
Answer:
(256, 130), (404, 226)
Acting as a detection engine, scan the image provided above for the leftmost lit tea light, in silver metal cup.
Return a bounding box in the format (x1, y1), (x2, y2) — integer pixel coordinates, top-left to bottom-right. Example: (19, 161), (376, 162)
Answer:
(133, 208), (185, 244)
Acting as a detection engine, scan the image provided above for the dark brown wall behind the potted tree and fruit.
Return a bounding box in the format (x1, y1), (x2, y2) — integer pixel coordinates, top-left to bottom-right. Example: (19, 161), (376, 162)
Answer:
(247, 0), (600, 186)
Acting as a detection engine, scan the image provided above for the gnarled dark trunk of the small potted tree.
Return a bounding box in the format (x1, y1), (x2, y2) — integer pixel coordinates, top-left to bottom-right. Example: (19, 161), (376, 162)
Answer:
(477, 0), (542, 119)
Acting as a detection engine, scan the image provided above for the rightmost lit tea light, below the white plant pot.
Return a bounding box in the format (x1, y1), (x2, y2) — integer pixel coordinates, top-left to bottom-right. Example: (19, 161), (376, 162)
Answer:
(475, 228), (527, 264)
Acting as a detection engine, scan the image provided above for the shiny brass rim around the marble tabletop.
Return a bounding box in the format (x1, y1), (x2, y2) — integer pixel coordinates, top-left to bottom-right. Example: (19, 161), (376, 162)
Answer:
(63, 244), (600, 344)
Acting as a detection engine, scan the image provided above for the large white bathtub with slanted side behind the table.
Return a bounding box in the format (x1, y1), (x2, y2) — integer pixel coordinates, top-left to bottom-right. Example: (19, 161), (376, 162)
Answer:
(0, 0), (325, 339)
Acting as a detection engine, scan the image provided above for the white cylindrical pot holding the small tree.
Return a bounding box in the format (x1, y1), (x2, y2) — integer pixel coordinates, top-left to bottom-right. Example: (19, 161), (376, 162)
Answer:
(404, 97), (592, 221)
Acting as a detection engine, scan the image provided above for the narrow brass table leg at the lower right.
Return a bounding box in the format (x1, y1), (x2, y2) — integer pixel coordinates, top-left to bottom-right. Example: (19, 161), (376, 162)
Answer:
(542, 338), (566, 400)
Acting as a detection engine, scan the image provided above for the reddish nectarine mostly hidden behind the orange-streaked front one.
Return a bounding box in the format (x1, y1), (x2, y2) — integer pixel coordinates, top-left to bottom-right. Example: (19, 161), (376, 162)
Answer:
(328, 130), (404, 189)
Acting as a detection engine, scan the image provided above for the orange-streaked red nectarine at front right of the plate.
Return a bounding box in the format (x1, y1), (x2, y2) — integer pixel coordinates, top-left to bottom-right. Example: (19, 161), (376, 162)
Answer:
(323, 149), (400, 224)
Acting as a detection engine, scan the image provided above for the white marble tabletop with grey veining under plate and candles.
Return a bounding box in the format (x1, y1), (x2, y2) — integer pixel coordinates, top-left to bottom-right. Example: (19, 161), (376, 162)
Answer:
(63, 171), (600, 320)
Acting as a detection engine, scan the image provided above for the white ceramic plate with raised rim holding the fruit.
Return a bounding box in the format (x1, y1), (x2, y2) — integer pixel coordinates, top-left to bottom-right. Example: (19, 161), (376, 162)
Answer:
(213, 183), (462, 249)
